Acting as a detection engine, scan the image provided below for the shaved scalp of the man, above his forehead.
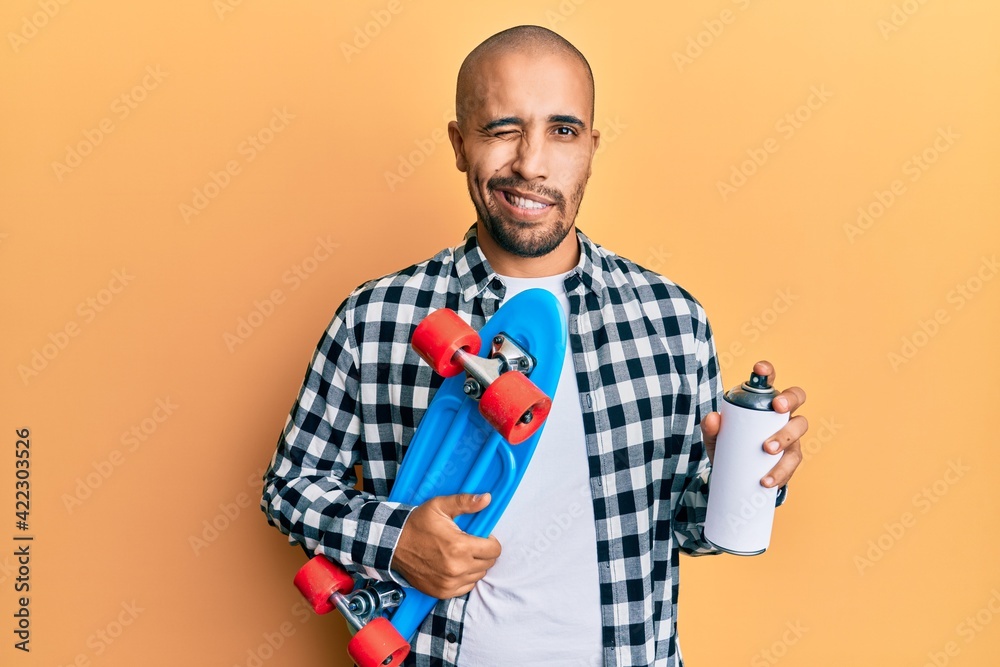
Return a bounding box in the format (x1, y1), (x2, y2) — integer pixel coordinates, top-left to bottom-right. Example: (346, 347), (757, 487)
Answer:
(455, 25), (594, 128)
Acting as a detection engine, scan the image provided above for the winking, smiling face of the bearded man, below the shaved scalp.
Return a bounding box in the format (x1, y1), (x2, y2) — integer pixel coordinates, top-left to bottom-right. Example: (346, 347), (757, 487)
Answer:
(448, 53), (600, 257)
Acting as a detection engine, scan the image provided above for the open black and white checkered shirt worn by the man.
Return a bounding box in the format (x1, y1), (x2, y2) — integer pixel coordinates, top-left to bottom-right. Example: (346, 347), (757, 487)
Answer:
(261, 227), (720, 667)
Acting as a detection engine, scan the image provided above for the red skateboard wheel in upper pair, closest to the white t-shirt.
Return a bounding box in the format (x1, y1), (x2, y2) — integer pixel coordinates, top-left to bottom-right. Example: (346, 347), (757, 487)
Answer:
(479, 371), (552, 445)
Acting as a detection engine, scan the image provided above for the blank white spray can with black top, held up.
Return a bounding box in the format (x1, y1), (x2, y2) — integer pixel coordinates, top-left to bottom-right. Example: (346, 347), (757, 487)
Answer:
(705, 373), (788, 556)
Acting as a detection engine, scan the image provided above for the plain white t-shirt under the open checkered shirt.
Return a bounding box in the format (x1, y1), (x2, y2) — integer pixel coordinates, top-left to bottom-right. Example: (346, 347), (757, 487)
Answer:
(458, 276), (603, 667)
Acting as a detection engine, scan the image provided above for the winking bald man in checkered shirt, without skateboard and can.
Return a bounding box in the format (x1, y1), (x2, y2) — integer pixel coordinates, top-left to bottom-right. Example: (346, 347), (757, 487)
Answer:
(262, 26), (807, 667)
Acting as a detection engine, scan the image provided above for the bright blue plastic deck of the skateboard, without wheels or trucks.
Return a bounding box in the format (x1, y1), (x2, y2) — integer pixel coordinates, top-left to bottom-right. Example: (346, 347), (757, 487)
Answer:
(389, 289), (567, 641)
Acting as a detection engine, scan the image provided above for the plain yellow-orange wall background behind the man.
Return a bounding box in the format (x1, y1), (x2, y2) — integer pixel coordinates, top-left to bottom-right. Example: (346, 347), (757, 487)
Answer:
(0, 0), (1000, 667)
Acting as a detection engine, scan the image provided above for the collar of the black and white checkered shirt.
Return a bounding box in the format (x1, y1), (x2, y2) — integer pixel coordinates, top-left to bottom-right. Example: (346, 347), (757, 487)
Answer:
(455, 224), (607, 302)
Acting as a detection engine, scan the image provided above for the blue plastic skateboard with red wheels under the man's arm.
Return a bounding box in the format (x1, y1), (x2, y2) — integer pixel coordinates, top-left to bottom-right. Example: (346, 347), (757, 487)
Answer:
(295, 289), (567, 667)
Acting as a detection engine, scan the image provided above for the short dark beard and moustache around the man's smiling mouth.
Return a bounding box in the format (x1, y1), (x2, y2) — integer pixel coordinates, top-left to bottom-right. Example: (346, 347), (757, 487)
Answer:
(469, 176), (586, 257)
